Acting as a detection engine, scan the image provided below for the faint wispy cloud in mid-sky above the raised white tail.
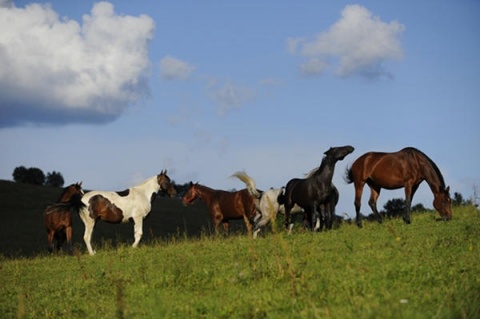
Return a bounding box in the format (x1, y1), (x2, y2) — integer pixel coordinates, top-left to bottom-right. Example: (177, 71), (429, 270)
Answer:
(208, 82), (257, 115)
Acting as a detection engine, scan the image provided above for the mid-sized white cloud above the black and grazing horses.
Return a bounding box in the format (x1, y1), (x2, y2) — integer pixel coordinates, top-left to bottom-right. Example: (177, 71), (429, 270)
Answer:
(287, 5), (405, 77)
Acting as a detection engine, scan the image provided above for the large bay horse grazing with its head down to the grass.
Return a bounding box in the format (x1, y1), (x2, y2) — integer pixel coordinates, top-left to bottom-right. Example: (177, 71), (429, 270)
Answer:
(345, 147), (452, 227)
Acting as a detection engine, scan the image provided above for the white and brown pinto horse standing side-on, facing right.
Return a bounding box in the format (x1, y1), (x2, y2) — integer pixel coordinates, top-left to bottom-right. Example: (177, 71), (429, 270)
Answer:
(80, 170), (177, 255)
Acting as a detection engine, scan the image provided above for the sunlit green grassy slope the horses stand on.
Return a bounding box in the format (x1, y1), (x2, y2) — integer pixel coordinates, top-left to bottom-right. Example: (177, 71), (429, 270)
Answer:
(0, 207), (480, 319)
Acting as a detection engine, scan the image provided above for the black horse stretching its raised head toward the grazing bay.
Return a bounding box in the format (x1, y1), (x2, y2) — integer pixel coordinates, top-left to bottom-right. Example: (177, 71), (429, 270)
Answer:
(283, 145), (354, 230)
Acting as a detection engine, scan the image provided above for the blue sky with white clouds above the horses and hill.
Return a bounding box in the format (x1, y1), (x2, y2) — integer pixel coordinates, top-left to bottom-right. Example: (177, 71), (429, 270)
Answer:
(0, 0), (480, 218)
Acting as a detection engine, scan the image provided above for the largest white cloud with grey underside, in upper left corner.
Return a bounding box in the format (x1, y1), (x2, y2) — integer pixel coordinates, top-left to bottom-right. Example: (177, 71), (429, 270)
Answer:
(0, 1), (155, 128)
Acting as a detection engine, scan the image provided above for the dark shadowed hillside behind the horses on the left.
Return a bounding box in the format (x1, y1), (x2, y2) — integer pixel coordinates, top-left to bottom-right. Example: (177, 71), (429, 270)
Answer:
(0, 180), (244, 256)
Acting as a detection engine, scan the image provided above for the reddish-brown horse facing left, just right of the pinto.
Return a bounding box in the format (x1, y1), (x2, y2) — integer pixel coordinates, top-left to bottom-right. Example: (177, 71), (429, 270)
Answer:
(182, 182), (256, 234)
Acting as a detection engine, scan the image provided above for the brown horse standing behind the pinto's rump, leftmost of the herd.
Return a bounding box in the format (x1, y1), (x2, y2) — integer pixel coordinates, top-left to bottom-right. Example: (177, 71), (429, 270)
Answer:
(43, 182), (83, 252)
